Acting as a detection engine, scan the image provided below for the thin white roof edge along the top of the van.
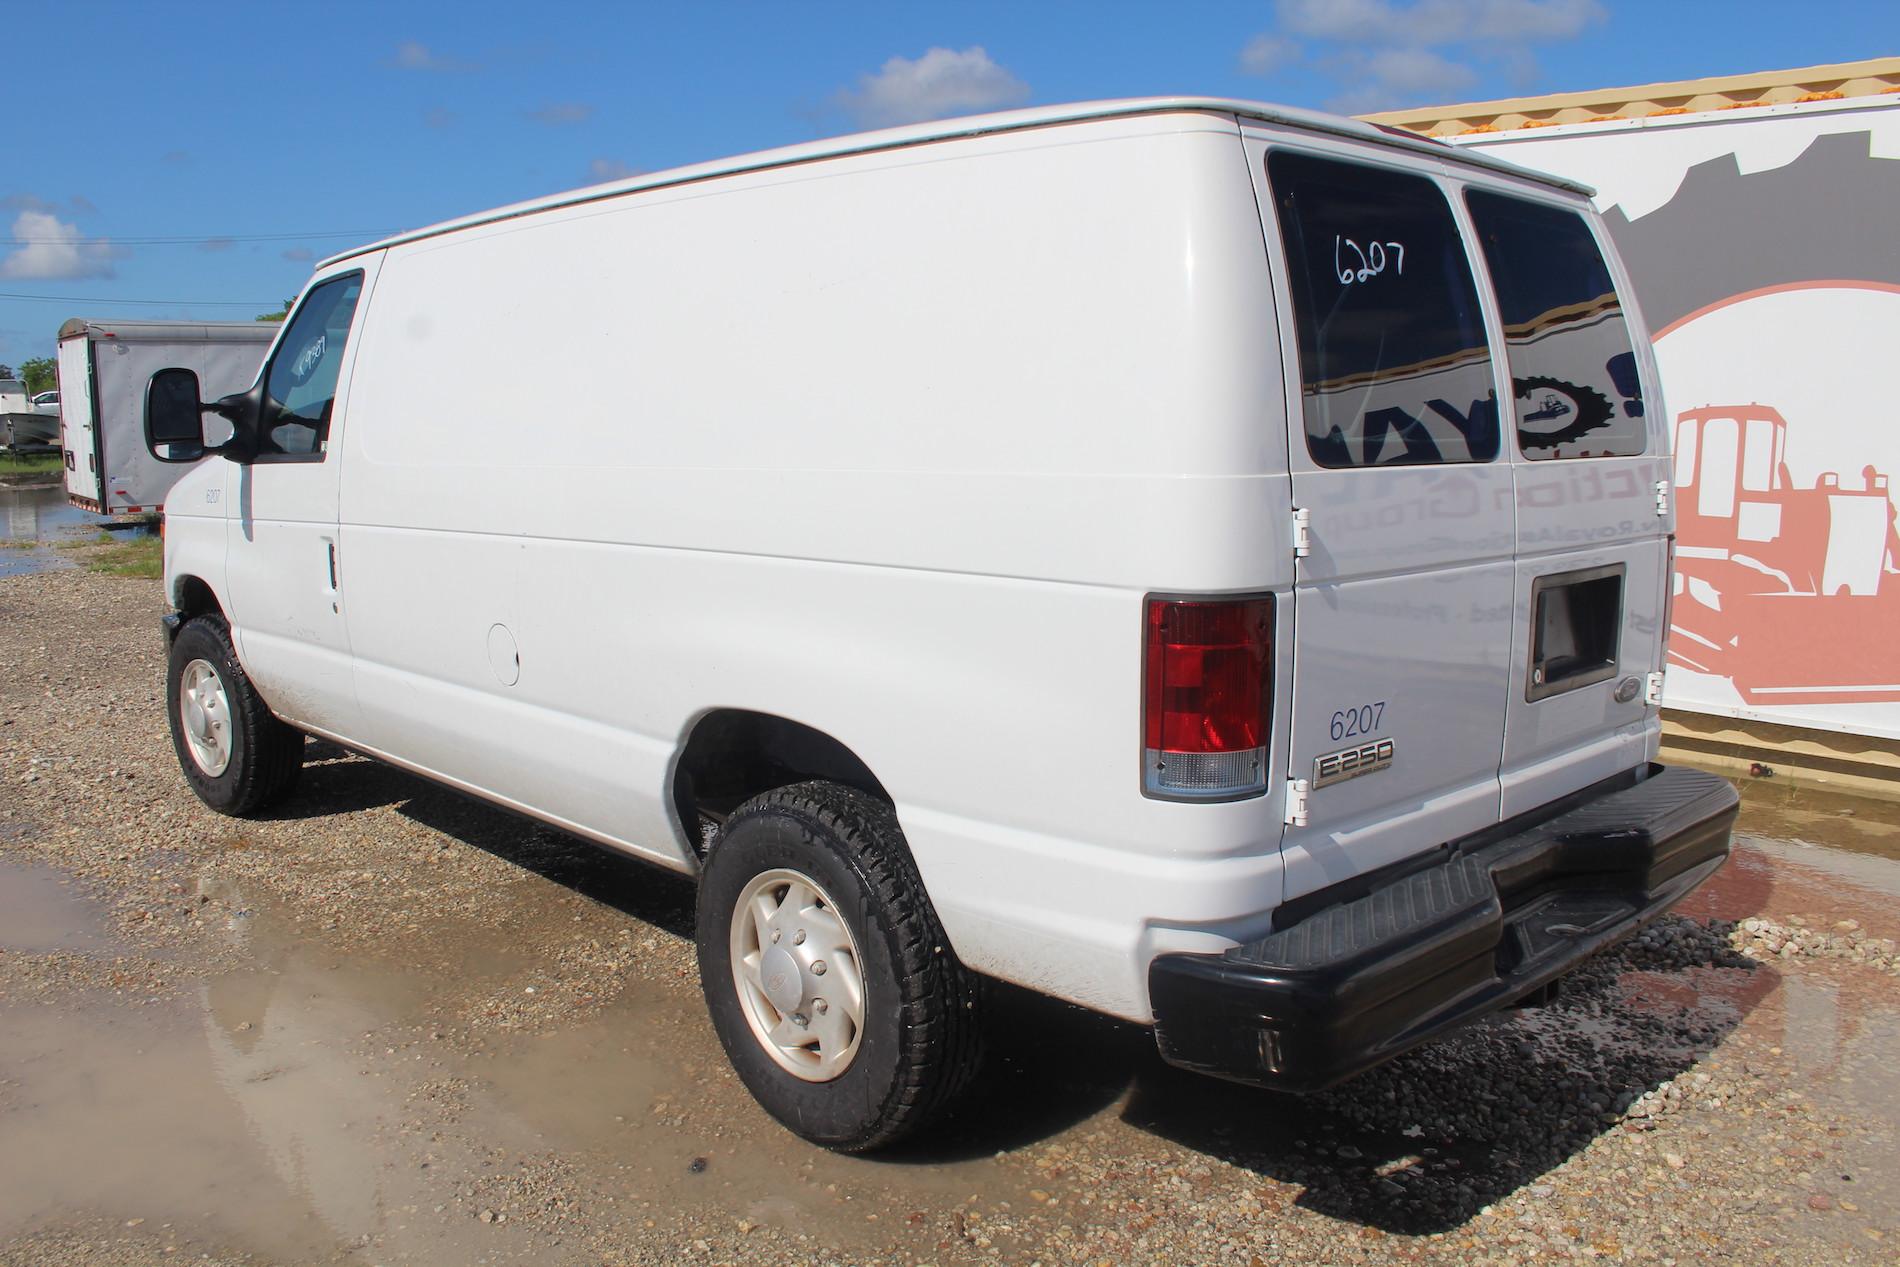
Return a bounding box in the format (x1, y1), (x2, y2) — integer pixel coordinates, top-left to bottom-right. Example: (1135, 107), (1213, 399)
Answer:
(317, 97), (1596, 268)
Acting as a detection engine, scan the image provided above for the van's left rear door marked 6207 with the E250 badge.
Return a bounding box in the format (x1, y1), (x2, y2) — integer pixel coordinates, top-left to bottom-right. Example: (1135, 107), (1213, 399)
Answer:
(1248, 133), (1516, 898)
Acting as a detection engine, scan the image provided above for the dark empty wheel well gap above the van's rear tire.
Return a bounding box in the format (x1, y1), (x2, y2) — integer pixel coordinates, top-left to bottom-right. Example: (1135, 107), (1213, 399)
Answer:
(673, 709), (891, 851)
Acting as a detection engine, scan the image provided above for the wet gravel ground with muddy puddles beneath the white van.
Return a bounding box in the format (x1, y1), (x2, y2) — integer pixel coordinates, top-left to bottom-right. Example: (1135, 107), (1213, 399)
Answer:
(0, 572), (1900, 1267)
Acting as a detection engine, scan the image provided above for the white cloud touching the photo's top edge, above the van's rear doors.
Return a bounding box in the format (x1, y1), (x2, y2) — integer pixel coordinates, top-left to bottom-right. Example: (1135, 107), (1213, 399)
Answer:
(1279, 0), (1606, 46)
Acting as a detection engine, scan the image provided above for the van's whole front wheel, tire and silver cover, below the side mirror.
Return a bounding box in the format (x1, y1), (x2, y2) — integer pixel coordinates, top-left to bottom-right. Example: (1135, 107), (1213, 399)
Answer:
(165, 615), (304, 817)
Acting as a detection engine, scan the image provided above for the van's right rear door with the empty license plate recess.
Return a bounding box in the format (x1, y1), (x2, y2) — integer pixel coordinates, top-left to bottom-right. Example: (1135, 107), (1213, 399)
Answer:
(1461, 186), (1668, 817)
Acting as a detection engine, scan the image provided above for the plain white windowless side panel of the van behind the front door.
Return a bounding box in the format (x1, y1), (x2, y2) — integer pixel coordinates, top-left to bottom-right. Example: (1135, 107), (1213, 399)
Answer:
(338, 114), (1292, 1020)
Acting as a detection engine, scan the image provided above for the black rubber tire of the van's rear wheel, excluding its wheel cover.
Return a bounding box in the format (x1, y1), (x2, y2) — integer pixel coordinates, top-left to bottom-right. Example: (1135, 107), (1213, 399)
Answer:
(697, 783), (982, 1153)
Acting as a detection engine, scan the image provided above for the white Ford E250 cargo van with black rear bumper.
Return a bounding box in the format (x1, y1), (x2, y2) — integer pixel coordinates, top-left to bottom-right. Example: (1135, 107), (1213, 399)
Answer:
(146, 99), (1737, 1149)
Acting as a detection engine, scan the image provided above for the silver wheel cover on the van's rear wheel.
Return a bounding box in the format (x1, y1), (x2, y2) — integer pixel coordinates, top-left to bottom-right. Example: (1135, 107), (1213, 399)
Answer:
(730, 868), (865, 1083)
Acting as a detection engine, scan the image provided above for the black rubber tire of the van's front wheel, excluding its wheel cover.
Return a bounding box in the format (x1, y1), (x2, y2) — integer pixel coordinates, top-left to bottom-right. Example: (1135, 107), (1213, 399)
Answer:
(165, 615), (304, 817)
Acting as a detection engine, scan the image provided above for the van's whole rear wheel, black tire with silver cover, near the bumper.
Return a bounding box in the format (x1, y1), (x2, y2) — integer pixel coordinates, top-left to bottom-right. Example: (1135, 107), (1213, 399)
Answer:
(697, 783), (980, 1153)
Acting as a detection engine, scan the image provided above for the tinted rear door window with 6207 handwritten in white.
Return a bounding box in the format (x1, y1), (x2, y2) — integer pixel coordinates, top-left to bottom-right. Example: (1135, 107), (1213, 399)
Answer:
(1267, 150), (1499, 467)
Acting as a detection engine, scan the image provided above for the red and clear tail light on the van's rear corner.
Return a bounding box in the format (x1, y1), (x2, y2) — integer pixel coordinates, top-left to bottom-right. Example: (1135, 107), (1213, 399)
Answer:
(1142, 598), (1273, 800)
